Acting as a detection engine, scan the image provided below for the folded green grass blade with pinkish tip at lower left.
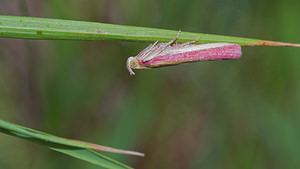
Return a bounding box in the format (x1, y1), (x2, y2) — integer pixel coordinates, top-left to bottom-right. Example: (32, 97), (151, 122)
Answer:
(0, 120), (144, 168)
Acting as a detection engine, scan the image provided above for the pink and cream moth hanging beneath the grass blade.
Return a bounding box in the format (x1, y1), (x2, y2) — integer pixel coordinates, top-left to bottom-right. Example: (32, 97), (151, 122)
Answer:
(126, 30), (242, 75)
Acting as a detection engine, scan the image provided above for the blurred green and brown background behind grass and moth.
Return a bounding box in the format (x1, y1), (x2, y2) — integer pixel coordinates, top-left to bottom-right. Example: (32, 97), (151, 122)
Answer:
(0, 0), (300, 169)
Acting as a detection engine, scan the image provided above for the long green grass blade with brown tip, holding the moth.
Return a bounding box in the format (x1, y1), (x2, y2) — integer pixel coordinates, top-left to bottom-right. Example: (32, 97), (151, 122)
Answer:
(0, 15), (300, 47)
